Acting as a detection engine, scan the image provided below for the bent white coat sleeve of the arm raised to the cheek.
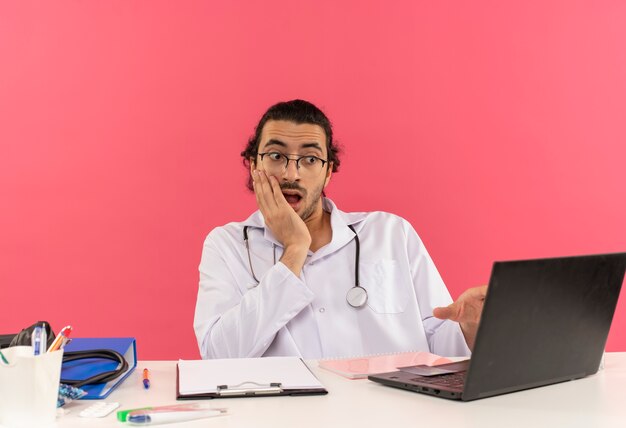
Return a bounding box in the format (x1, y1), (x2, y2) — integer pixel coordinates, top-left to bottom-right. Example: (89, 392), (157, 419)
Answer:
(194, 234), (314, 358)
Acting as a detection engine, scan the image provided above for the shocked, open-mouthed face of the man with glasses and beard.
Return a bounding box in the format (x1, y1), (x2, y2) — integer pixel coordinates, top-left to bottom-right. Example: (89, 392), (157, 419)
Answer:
(250, 120), (332, 220)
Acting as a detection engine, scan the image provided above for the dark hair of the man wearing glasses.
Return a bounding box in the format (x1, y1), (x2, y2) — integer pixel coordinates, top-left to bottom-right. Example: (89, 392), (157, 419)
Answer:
(241, 100), (340, 190)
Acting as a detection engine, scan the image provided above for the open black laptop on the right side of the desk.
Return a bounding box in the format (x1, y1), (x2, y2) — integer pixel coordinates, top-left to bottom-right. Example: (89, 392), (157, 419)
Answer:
(368, 253), (626, 401)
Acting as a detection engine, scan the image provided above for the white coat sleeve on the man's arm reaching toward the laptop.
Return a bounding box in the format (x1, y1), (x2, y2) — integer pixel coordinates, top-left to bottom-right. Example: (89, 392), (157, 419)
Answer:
(406, 222), (471, 357)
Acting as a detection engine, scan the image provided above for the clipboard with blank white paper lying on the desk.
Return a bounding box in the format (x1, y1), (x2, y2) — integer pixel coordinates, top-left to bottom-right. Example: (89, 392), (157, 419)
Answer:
(176, 357), (328, 400)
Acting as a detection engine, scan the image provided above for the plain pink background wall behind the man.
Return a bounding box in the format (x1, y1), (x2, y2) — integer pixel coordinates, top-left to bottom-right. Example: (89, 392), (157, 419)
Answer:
(0, 0), (626, 359)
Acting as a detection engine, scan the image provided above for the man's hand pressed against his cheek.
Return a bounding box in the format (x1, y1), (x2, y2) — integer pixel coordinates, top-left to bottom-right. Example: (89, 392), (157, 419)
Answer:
(252, 170), (311, 275)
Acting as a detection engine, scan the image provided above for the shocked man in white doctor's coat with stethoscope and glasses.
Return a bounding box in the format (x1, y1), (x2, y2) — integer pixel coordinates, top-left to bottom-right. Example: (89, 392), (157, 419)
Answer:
(194, 100), (485, 358)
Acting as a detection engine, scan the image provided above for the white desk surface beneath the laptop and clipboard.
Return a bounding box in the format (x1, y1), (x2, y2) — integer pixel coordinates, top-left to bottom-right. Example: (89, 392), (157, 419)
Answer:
(57, 353), (626, 428)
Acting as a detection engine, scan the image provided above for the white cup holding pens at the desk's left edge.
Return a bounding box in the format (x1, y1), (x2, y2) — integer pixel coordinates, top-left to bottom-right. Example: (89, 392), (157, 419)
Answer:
(0, 346), (63, 428)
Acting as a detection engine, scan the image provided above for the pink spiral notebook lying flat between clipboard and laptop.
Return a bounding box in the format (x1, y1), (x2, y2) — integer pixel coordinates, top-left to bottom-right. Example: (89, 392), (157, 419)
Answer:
(319, 352), (452, 379)
